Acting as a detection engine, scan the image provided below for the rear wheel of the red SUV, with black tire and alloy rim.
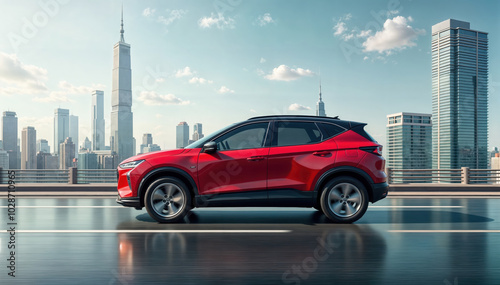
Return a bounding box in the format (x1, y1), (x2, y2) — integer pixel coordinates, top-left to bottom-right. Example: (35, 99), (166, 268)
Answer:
(320, 176), (369, 223)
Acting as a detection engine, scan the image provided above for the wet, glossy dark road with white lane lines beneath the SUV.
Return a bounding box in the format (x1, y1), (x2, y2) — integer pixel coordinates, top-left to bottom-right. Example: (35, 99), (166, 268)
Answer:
(0, 197), (500, 285)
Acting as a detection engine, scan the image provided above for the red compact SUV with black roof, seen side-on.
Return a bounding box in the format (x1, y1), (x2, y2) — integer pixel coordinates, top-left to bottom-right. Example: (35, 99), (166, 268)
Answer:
(117, 116), (388, 223)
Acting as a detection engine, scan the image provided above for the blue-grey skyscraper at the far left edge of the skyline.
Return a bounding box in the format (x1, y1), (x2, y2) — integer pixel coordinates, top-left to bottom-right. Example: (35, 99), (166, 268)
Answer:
(2, 111), (20, 169)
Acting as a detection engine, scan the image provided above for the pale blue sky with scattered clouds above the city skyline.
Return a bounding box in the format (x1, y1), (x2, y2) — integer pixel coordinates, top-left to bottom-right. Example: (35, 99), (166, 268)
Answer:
(0, 0), (500, 149)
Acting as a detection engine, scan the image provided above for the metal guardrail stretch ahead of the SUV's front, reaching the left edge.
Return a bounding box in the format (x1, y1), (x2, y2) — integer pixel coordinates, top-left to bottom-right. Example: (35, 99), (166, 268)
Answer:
(0, 167), (118, 184)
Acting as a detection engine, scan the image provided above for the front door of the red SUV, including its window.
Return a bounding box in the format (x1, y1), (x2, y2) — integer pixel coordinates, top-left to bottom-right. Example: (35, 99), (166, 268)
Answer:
(198, 122), (269, 199)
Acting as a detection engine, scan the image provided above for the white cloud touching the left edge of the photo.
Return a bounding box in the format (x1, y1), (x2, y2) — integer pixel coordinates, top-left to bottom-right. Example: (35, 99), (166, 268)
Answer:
(0, 52), (48, 95)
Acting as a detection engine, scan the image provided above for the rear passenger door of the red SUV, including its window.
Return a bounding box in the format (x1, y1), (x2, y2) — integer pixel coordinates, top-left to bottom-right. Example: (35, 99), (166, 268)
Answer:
(268, 121), (337, 195)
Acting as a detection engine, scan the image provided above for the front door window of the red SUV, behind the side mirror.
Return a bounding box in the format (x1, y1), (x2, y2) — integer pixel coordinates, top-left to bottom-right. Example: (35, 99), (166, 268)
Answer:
(214, 122), (269, 151)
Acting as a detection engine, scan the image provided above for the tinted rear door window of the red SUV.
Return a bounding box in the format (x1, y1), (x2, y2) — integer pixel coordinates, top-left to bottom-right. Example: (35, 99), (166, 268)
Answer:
(274, 121), (322, 146)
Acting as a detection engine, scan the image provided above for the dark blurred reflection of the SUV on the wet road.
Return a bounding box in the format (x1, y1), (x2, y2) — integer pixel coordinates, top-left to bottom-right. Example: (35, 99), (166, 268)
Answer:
(118, 213), (386, 284)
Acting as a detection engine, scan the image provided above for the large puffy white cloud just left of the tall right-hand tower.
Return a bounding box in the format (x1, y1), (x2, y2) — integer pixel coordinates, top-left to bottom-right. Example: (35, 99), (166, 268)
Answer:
(363, 16), (425, 54)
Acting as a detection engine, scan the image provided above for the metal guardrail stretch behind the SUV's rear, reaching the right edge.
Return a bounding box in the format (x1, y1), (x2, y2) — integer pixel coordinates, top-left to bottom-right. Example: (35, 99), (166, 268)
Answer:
(386, 167), (500, 184)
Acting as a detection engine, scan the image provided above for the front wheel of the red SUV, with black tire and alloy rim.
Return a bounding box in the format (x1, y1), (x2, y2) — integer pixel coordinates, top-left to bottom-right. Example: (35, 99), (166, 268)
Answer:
(144, 177), (191, 223)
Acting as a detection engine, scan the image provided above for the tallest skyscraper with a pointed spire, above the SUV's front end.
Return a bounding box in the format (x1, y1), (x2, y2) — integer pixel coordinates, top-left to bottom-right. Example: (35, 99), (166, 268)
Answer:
(110, 10), (135, 161)
